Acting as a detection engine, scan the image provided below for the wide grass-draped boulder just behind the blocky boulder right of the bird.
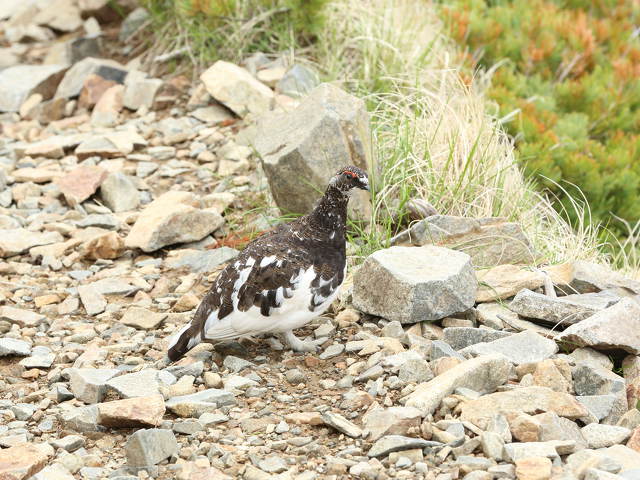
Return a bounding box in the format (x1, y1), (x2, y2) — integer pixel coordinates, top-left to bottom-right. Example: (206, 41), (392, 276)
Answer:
(391, 215), (538, 268)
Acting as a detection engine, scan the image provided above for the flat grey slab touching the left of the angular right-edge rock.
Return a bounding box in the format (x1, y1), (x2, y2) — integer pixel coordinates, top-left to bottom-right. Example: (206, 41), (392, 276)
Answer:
(509, 289), (601, 326)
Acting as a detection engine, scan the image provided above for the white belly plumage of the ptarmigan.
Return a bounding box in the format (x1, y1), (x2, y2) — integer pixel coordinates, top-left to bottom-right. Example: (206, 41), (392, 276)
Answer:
(204, 268), (340, 340)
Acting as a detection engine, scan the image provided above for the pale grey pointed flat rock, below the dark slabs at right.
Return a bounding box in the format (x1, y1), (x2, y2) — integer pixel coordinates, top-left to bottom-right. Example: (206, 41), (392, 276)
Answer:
(462, 330), (558, 365)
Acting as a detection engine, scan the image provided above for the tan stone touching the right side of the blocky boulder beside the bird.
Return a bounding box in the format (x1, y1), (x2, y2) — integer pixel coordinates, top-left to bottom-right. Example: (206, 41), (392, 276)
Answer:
(476, 265), (544, 302)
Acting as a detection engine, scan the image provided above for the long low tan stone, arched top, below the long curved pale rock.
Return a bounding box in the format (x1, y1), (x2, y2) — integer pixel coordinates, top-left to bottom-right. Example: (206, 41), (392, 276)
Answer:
(460, 384), (588, 429)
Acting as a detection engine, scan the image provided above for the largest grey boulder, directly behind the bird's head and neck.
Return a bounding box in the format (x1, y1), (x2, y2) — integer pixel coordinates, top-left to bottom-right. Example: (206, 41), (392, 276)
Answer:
(255, 83), (372, 218)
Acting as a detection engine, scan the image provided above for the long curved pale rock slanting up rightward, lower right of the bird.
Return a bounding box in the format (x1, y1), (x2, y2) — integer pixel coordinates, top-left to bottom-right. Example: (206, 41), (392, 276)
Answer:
(405, 355), (513, 416)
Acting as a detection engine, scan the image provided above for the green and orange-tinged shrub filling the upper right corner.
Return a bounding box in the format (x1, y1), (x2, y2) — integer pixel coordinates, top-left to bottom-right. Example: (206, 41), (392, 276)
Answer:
(442, 0), (640, 236)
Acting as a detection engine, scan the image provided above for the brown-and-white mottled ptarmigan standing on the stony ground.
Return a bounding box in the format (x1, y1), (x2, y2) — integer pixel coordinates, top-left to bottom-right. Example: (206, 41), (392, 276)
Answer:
(167, 166), (369, 361)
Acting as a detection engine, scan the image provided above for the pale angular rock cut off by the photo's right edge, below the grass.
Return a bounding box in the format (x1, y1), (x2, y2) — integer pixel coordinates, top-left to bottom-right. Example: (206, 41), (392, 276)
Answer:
(557, 298), (640, 355)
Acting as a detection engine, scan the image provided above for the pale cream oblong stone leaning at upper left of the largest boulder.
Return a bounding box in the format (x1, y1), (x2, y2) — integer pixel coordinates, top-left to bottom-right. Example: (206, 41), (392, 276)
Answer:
(200, 60), (274, 117)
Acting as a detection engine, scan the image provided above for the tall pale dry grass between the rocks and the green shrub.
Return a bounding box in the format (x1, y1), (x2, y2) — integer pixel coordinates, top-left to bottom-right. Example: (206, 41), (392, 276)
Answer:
(317, 0), (607, 263)
